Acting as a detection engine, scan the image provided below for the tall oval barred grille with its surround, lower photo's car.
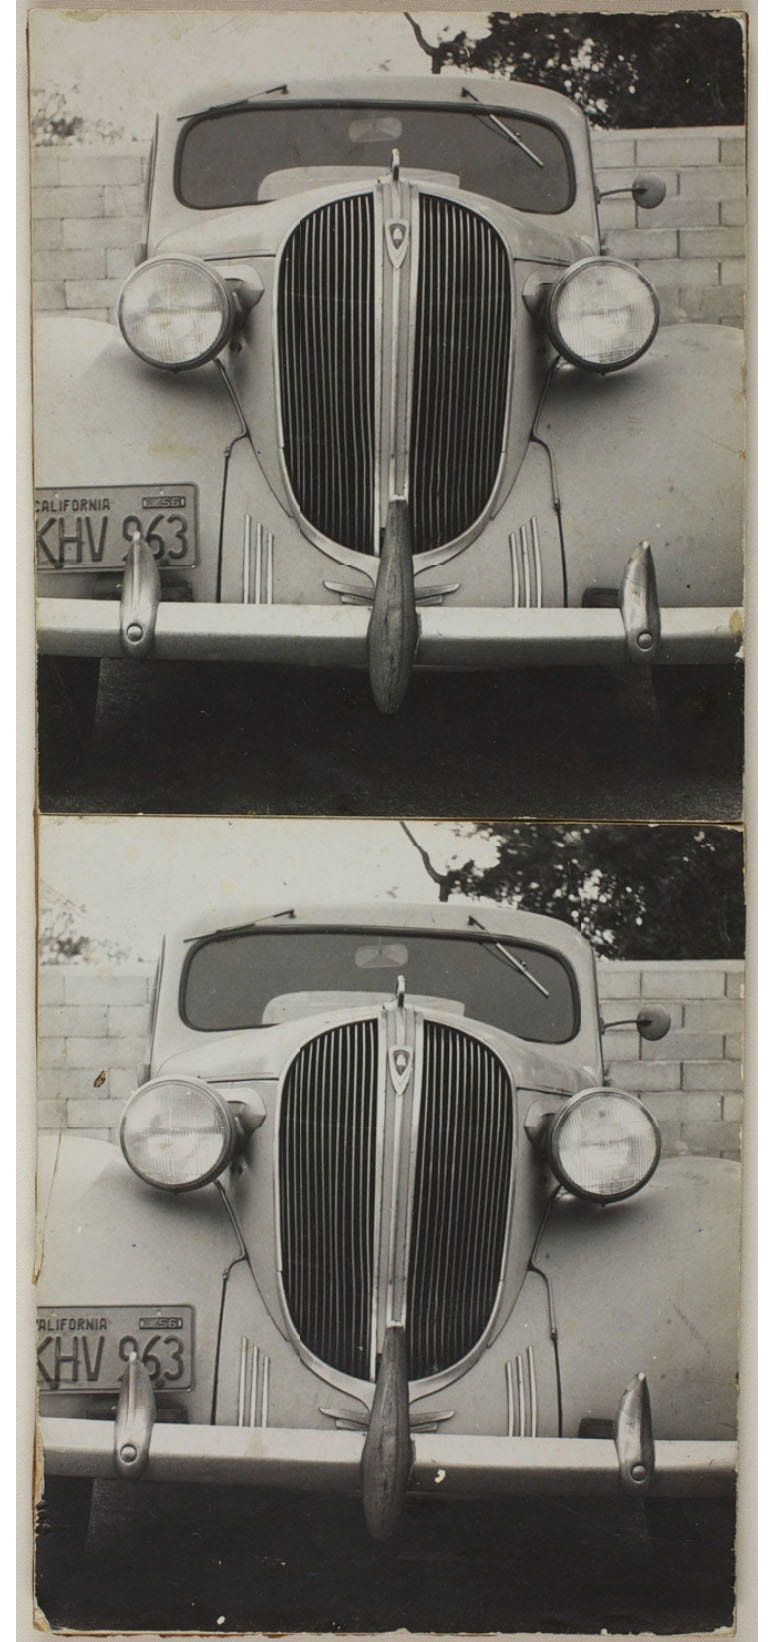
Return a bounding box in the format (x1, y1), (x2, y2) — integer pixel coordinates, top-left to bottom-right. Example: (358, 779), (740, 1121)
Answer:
(276, 1008), (517, 1386)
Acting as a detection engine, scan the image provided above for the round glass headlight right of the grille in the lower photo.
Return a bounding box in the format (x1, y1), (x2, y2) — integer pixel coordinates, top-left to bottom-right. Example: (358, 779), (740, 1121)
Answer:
(550, 1089), (660, 1204)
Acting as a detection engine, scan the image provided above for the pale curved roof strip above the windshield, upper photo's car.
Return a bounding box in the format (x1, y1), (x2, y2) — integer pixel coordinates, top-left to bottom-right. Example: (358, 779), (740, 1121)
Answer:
(174, 74), (586, 126)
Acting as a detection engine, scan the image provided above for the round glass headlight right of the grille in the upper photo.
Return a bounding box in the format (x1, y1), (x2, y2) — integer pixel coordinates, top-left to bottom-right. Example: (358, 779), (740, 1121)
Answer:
(546, 256), (660, 371)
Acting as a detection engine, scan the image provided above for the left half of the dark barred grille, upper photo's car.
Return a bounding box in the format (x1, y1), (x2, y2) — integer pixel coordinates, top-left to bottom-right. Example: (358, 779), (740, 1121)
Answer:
(277, 194), (374, 552)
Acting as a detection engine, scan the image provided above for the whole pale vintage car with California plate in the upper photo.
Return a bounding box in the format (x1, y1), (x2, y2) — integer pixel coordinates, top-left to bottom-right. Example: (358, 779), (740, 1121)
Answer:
(34, 74), (743, 737)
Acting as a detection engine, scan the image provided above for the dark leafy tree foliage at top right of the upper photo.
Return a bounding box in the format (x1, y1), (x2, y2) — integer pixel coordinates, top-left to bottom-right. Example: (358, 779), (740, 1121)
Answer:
(405, 11), (745, 128)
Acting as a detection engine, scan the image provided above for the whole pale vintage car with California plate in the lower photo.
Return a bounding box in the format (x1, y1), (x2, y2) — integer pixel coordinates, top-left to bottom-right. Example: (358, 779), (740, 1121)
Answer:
(38, 901), (738, 1602)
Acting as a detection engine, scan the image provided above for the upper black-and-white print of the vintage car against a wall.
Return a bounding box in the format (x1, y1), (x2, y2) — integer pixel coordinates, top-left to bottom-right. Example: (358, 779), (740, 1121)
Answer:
(30, 8), (746, 821)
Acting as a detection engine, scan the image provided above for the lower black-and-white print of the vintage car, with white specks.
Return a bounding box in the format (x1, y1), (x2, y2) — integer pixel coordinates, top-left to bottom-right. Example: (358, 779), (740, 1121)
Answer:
(36, 818), (743, 1635)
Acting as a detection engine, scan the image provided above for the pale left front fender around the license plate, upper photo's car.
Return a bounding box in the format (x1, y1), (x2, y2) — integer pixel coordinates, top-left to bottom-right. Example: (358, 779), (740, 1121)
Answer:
(34, 319), (243, 599)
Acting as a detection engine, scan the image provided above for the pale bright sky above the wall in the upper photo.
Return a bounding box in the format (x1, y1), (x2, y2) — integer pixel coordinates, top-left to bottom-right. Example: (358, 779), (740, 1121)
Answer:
(30, 10), (487, 136)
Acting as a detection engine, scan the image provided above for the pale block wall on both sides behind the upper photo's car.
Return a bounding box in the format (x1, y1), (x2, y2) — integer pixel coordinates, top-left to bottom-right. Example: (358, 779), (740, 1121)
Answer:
(33, 126), (745, 325)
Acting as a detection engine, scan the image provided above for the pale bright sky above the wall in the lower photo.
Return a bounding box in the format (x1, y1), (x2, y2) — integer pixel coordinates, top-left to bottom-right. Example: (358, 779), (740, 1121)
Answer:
(39, 816), (494, 959)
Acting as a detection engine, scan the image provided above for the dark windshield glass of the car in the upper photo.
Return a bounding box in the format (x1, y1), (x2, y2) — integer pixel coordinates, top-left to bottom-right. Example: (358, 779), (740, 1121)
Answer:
(176, 103), (574, 215)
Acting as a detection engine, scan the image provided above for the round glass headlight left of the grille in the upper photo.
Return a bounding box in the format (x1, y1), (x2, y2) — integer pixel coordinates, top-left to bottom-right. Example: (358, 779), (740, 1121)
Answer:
(118, 256), (235, 371)
